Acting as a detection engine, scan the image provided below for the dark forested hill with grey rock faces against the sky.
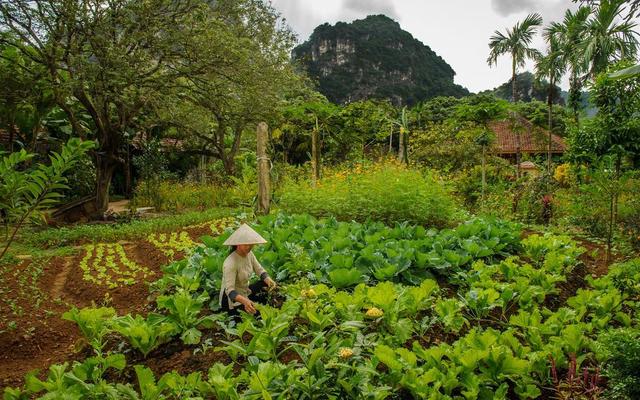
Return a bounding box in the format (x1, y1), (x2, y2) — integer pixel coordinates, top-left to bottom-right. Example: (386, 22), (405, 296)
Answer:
(292, 15), (469, 105)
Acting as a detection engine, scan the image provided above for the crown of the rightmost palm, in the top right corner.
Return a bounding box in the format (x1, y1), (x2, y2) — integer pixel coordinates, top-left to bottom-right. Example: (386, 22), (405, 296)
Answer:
(582, 0), (638, 79)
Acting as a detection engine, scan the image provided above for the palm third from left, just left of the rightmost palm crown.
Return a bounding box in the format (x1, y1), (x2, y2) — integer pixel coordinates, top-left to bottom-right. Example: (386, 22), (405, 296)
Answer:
(545, 6), (591, 122)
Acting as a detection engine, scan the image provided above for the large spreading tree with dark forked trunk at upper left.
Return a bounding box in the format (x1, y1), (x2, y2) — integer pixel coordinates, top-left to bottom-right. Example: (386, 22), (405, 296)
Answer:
(0, 0), (292, 216)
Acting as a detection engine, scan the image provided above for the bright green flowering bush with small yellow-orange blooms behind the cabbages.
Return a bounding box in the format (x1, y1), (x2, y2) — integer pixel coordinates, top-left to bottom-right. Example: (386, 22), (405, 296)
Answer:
(280, 162), (456, 227)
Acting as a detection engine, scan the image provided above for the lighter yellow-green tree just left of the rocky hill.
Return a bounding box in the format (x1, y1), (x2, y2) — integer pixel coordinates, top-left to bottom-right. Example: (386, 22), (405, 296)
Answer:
(162, 0), (300, 175)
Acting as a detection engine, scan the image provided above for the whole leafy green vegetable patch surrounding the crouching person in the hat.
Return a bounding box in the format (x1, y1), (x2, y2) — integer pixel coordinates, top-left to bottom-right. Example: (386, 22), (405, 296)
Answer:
(5, 213), (640, 399)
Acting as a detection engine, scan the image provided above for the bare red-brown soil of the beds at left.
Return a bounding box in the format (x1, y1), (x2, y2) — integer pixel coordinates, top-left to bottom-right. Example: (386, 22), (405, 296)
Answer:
(0, 225), (218, 393)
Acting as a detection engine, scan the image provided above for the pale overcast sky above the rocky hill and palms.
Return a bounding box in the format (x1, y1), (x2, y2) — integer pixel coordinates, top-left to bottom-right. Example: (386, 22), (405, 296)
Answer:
(272, 0), (640, 92)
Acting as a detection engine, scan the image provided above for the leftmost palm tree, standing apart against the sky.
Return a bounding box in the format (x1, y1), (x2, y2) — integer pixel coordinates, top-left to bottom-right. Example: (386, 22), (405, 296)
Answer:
(487, 13), (542, 178)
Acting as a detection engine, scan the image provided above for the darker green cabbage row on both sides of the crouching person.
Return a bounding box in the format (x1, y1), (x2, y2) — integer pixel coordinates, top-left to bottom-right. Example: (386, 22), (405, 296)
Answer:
(156, 214), (520, 292)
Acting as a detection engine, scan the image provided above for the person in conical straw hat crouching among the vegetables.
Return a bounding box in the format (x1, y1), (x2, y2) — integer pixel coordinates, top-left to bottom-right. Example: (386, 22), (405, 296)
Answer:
(220, 224), (276, 315)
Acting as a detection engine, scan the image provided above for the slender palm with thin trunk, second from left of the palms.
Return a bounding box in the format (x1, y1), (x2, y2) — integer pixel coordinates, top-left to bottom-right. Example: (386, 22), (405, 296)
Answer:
(536, 26), (566, 174)
